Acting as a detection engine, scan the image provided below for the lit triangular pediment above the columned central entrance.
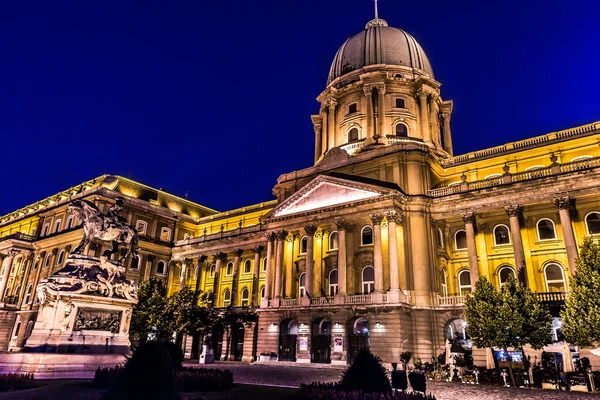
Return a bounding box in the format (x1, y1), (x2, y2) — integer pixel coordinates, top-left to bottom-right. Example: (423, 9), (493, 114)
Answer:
(265, 175), (391, 218)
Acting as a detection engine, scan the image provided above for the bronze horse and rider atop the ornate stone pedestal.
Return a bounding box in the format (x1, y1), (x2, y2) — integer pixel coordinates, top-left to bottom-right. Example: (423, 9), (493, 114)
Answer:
(68, 199), (139, 261)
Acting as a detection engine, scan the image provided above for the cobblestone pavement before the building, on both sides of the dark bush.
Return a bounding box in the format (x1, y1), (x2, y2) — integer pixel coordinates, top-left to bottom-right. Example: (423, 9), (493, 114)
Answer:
(188, 363), (600, 400)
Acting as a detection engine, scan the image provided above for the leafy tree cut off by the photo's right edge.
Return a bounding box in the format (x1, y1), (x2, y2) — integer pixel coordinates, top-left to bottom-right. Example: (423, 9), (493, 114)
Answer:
(561, 239), (600, 346)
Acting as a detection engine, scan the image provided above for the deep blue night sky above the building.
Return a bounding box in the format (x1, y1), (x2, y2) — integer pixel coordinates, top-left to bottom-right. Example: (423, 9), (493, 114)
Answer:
(0, 0), (600, 214)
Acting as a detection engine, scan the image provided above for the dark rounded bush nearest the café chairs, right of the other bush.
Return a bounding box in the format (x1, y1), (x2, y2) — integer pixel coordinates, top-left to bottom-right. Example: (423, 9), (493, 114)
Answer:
(340, 349), (392, 393)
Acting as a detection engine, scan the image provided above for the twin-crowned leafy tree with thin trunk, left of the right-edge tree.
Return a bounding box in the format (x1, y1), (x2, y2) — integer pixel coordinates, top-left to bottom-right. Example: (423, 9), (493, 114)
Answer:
(465, 277), (552, 386)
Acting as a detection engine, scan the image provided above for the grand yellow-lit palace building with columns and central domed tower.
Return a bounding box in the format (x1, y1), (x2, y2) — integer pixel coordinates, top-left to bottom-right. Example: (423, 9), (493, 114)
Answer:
(0, 10), (600, 364)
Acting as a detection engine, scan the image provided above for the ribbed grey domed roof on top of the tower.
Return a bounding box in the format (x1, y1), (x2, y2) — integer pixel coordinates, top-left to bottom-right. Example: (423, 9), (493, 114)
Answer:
(327, 18), (433, 85)
